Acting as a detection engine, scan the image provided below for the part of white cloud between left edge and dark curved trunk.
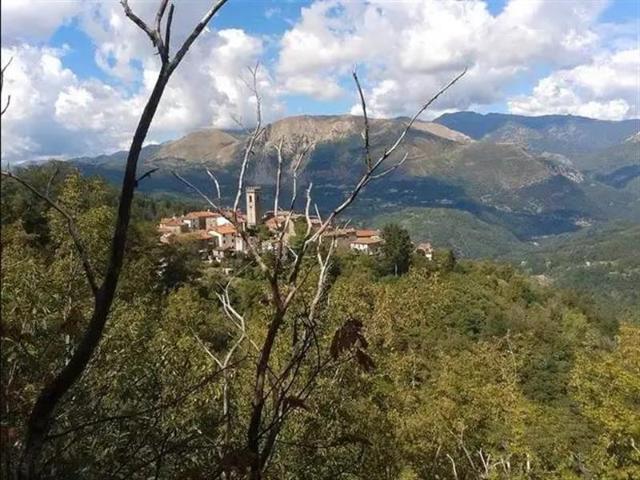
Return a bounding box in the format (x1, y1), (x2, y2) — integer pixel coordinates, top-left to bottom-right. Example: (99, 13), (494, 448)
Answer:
(2, 44), (136, 161)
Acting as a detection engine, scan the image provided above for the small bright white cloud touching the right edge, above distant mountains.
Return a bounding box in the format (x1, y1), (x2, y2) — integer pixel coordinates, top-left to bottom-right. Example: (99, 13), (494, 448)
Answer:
(508, 48), (640, 120)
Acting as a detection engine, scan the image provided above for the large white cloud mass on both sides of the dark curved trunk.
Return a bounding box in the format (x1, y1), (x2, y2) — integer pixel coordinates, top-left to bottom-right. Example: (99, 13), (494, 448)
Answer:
(2, 2), (283, 162)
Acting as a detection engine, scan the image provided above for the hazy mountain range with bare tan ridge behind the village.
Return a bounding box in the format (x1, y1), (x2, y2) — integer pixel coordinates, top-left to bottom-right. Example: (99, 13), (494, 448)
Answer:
(73, 112), (640, 255)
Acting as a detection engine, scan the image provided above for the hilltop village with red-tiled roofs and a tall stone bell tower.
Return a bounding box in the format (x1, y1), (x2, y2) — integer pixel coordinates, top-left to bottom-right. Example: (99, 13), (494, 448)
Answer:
(158, 187), (433, 262)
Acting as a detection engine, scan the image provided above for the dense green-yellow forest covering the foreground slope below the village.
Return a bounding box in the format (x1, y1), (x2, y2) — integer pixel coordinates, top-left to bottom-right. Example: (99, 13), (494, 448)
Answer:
(1, 164), (640, 480)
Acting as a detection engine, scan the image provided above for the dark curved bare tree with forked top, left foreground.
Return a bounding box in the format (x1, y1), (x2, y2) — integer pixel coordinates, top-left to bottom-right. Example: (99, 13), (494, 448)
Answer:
(0, 0), (227, 479)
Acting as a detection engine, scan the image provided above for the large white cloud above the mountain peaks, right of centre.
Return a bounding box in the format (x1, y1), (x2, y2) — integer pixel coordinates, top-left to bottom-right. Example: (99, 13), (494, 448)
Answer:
(277, 0), (620, 117)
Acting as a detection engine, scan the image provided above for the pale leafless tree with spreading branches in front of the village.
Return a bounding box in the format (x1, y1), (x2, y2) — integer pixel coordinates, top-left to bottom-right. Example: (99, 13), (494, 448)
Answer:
(174, 68), (466, 480)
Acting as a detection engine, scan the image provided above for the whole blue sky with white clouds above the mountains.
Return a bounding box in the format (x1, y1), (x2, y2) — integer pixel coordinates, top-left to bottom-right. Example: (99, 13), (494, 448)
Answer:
(1, 0), (640, 163)
